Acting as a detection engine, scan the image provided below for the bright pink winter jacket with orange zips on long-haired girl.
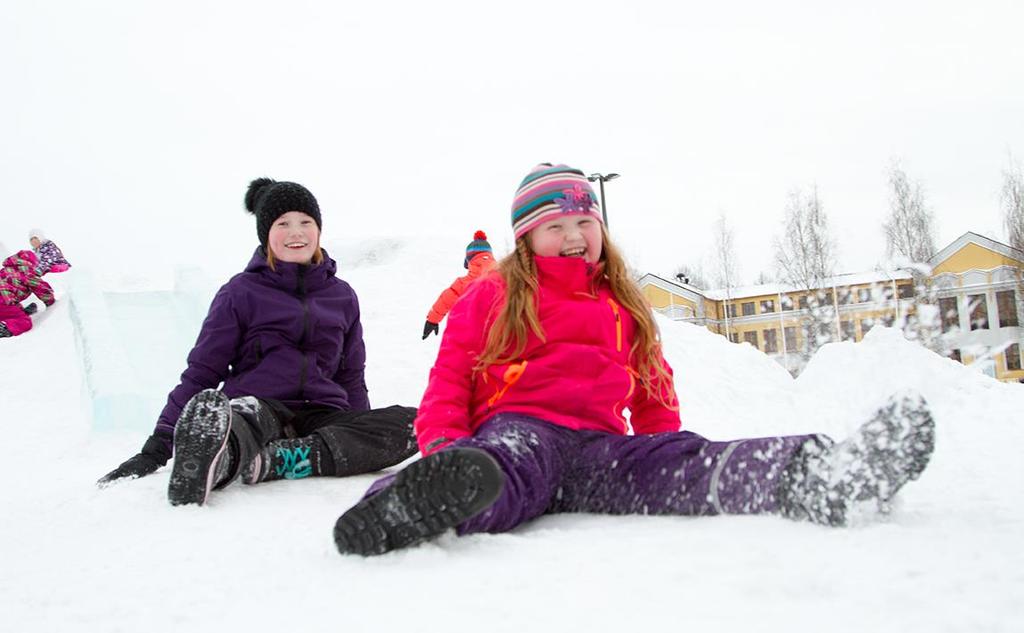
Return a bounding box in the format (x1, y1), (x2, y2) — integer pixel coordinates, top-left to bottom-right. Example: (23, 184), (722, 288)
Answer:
(415, 257), (680, 455)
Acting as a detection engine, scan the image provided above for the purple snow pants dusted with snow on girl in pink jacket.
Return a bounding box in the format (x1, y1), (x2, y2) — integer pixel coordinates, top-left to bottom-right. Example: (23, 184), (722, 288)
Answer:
(367, 414), (827, 534)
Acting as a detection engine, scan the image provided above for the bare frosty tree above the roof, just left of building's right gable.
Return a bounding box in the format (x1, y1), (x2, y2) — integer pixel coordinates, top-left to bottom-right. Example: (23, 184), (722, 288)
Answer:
(882, 163), (935, 263)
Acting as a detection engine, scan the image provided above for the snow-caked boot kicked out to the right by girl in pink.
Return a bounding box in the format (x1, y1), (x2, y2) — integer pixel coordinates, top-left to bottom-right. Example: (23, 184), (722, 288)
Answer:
(778, 393), (935, 525)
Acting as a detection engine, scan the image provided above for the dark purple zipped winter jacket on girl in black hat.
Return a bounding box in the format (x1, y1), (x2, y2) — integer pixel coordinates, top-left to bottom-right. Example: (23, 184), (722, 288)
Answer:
(157, 247), (370, 438)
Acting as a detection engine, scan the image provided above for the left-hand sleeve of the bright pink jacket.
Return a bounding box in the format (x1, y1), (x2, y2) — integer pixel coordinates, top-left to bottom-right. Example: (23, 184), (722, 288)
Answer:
(414, 280), (501, 455)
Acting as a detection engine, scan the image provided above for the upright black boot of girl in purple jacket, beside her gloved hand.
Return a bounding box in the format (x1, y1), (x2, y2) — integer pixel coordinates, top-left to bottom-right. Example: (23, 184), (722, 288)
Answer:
(167, 389), (231, 506)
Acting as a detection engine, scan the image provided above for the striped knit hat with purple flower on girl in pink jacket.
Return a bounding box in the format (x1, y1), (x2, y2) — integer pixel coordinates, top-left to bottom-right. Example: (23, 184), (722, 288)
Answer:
(512, 163), (601, 238)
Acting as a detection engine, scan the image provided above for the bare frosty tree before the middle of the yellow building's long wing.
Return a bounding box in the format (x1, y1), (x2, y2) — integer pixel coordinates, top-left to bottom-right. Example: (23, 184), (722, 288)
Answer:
(775, 186), (837, 361)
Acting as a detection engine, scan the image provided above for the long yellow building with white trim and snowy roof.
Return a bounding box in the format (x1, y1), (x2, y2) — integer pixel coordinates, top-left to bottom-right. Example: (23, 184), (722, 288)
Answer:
(639, 233), (1024, 382)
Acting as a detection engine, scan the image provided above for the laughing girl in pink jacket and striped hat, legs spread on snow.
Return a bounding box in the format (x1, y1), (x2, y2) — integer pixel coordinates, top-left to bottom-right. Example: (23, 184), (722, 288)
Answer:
(334, 163), (934, 555)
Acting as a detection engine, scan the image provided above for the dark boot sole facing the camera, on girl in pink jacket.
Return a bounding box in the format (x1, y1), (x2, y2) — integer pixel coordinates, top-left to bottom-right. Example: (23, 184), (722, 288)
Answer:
(334, 449), (505, 556)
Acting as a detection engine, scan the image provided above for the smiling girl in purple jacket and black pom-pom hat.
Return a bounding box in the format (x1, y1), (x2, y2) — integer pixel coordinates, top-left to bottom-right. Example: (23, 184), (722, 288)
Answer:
(98, 178), (417, 505)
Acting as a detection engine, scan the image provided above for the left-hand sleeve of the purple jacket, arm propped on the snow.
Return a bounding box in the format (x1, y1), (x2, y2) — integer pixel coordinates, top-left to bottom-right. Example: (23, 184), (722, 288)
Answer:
(156, 285), (243, 436)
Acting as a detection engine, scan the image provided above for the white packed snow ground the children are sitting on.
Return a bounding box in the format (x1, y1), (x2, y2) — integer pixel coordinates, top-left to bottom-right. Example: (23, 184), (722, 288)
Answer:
(0, 238), (1024, 633)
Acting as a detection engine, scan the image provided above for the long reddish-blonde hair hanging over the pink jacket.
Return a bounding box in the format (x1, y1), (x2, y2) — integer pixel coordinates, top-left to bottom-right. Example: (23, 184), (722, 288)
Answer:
(474, 225), (677, 409)
